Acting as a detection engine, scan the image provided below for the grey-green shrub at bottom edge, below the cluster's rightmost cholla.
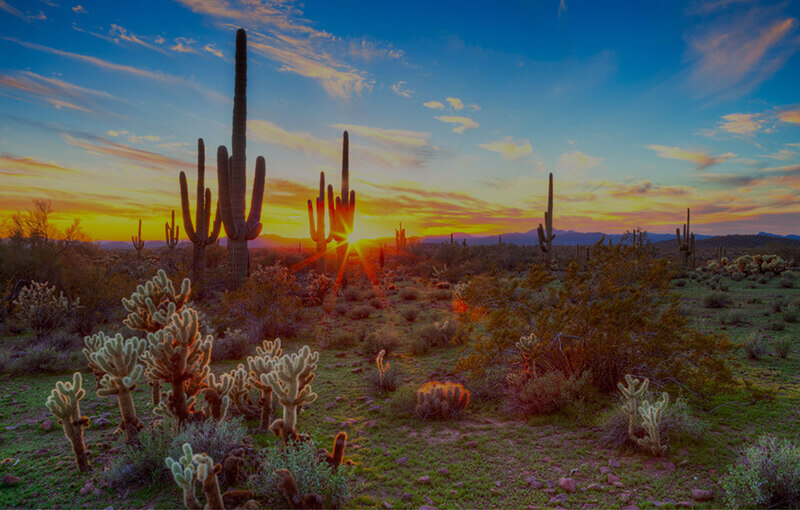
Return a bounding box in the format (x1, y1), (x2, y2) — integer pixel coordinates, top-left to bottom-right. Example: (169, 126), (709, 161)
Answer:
(248, 441), (354, 508)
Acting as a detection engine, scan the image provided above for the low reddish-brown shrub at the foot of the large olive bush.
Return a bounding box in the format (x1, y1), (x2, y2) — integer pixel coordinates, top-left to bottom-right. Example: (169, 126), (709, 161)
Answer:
(508, 371), (592, 416)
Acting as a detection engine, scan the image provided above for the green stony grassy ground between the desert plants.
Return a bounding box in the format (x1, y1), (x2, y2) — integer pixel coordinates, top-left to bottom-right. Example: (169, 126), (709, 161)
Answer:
(0, 268), (800, 508)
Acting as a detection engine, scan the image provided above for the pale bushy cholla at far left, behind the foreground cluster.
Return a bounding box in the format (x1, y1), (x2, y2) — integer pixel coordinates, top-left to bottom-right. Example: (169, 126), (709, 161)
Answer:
(14, 282), (80, 338)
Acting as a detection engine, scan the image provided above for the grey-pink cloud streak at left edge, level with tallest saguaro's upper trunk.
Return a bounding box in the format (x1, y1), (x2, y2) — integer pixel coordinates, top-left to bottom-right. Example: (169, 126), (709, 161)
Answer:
(0, 71), (116, 113)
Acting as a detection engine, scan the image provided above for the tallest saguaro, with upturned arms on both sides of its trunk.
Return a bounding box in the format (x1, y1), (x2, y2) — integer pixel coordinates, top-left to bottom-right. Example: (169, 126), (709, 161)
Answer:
(217, 28), (266, 289)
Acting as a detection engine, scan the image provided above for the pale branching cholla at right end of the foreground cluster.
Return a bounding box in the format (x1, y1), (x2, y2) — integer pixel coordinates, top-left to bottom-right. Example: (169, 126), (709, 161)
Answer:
(268, 345), (319, 445)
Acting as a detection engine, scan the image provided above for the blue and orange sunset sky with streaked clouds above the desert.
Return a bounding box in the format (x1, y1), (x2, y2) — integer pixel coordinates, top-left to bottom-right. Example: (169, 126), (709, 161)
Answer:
(0, 0), (800, 240)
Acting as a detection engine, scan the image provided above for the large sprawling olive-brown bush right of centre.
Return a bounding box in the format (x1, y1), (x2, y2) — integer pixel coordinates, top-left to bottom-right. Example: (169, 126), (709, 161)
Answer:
(453, 244), (732, 392)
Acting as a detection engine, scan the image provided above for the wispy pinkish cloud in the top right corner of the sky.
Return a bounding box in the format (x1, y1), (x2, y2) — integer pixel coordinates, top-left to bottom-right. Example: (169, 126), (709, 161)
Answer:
(687, 9), (800, 97)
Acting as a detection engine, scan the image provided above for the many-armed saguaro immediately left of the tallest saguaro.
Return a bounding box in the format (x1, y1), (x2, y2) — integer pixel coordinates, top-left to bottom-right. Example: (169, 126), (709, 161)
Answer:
(180, 138), (222, 285)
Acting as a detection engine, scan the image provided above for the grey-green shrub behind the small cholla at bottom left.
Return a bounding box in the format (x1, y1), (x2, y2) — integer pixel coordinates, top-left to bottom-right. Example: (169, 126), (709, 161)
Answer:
(104, 418), (247, 488)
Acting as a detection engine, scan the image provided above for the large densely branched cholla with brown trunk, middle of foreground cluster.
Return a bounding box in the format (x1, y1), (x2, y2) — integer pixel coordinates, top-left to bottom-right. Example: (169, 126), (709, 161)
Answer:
(142, 309), (214, 424)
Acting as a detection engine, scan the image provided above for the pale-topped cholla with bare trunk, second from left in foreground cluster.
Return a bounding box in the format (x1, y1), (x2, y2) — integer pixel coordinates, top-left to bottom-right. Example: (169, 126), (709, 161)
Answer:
(84, 333), (147, 442)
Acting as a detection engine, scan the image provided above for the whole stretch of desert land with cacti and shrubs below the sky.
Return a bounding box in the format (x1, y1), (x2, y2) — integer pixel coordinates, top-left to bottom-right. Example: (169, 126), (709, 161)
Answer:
(0, 25), (800, 509)
